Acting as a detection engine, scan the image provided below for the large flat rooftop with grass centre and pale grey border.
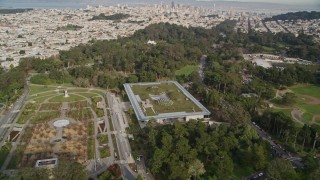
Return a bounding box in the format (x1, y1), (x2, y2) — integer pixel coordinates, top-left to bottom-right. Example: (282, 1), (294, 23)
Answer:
(124, 81), (210, 121)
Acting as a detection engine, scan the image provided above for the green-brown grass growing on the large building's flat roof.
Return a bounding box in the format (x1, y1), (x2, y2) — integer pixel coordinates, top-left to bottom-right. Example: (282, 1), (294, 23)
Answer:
(132, 83), (200, 115)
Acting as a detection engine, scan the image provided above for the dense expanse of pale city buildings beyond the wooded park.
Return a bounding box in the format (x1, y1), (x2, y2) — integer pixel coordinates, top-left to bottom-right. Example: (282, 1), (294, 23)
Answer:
(0, 3), (320, 68)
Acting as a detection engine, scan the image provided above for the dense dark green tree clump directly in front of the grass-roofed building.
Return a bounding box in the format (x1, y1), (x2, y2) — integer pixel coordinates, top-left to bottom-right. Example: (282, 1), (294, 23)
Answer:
(134, 120), (268, 179)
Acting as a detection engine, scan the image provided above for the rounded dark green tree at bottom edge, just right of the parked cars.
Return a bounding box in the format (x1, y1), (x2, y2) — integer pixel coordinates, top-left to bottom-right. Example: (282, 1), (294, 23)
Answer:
(266, 158), (298, 180)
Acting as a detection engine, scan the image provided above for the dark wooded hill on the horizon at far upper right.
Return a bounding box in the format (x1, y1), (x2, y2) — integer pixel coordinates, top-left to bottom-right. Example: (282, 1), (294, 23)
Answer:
(264, 11), (320, 21)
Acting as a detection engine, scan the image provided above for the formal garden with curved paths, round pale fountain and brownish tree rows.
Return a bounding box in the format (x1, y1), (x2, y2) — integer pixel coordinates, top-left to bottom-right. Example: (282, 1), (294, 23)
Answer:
(0, 85), (110, 169)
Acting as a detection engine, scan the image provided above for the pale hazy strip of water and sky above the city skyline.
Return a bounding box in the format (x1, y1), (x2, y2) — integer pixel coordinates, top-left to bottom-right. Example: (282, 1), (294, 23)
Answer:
(0, 0), (320, 11)
